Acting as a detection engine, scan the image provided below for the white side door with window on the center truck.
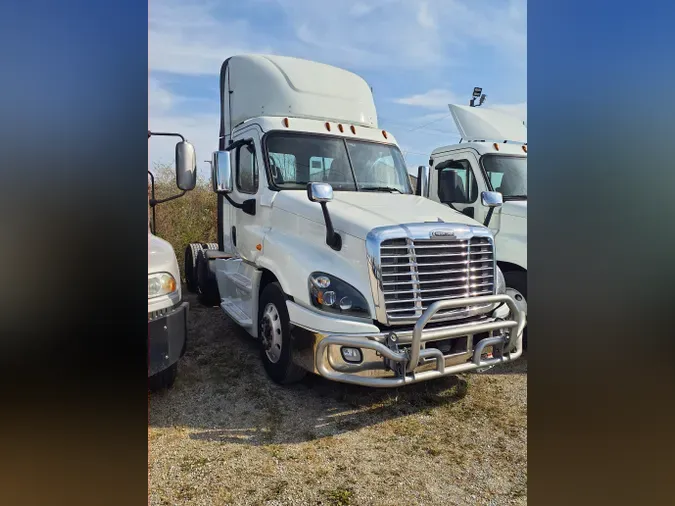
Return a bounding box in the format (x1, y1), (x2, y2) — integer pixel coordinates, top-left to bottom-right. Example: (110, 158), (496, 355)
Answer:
(230, 128), (265, 262)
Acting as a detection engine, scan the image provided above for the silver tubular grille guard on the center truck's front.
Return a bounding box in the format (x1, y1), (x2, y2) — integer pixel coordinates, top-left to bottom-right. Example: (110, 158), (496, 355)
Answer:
(315, 294), (526, 387)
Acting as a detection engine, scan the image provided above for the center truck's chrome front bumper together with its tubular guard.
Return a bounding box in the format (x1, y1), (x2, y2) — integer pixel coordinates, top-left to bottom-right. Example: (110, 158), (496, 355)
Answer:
(304, 294), (526, 387)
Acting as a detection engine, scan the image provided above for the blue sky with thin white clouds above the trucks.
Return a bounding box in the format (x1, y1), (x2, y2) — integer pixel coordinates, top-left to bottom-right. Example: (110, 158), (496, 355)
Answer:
(148, 0), (527, 174)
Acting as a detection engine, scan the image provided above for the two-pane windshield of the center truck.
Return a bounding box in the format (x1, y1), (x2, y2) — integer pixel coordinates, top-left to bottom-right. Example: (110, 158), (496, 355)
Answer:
(267, 133), (412, 193)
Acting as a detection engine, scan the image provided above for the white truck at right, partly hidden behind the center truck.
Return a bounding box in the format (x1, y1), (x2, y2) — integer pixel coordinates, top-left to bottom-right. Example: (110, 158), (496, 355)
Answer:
(416, 105), (527, 345)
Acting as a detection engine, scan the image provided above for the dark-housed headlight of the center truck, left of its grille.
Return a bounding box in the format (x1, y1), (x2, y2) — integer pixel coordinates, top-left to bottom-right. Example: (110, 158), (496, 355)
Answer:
(309, 272), (370, 318)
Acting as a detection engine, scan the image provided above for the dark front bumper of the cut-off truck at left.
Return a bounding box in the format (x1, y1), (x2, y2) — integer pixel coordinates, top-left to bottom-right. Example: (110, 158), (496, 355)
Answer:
(148, 302), (190, 377)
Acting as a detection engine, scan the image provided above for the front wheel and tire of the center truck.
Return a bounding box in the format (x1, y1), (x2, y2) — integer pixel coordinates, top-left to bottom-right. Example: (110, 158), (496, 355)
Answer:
(258, 283), (307, 385)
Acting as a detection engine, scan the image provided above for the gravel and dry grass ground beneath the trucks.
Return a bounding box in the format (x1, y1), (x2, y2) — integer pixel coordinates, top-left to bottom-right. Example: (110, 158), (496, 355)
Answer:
(148, 288), (527, 506)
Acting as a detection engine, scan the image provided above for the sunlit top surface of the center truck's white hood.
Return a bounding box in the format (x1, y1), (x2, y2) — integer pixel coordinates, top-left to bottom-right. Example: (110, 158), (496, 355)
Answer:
(273, 190), (480, 239)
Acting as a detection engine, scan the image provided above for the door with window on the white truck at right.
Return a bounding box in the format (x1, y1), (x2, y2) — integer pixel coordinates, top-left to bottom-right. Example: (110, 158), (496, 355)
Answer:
(429, 150), (487, 223)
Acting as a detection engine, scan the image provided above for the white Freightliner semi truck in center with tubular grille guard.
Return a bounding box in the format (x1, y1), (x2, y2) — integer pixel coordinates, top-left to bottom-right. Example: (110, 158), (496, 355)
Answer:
(196, 55), (525, 387)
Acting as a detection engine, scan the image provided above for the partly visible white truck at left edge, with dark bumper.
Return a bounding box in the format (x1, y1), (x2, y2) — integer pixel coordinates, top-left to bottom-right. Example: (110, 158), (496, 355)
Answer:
(148, 131), (197, 390)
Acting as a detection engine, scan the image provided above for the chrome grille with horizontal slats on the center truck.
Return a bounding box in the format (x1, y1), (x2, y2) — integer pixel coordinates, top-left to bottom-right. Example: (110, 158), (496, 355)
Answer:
(380, 236), (495, 323)
